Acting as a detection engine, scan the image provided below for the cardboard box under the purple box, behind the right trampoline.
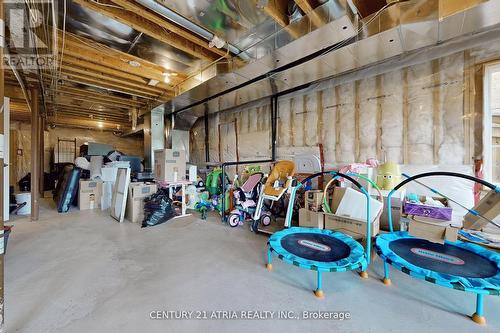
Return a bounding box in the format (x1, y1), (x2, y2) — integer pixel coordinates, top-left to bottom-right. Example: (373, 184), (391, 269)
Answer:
(408, 217), (459, 243)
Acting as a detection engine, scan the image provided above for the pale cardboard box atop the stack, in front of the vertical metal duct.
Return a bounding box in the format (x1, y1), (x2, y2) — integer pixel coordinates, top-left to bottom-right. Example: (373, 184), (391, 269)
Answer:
(154, 149), (186, 182)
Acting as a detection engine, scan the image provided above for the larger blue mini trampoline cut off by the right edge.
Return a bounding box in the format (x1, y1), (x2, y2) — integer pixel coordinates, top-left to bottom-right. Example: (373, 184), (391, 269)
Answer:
(375, 172), (500, 324)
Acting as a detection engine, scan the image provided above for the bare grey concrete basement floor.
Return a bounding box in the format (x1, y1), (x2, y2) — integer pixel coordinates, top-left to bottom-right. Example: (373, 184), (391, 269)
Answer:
(5, 198), (500, 333)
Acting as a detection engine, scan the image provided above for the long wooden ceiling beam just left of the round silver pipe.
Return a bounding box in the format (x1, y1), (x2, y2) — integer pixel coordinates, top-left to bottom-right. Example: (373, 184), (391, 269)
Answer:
(73, 0), (218, 62)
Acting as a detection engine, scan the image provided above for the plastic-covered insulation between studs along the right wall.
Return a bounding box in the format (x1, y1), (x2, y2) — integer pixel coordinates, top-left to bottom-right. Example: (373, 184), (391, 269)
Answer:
(191, 45), (494, 167)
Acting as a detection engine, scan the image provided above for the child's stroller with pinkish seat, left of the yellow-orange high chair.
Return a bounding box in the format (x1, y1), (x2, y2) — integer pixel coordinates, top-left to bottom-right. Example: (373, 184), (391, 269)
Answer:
(227, 172), (271, 227)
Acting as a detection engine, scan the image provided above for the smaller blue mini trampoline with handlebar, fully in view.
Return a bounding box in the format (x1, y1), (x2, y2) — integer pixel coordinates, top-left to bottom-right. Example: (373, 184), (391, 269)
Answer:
(266, 172), (371, 298)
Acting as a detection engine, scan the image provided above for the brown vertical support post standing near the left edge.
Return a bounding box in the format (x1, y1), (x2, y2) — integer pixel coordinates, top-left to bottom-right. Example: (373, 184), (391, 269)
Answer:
(31, 88), (40, 221)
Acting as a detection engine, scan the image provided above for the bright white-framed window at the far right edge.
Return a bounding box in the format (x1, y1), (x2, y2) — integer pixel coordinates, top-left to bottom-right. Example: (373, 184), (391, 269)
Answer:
(483, 63), (500, 184)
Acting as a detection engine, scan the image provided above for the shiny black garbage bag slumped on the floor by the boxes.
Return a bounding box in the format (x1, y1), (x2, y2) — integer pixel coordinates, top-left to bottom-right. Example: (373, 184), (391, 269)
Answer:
(142, 189), (177, 228)
